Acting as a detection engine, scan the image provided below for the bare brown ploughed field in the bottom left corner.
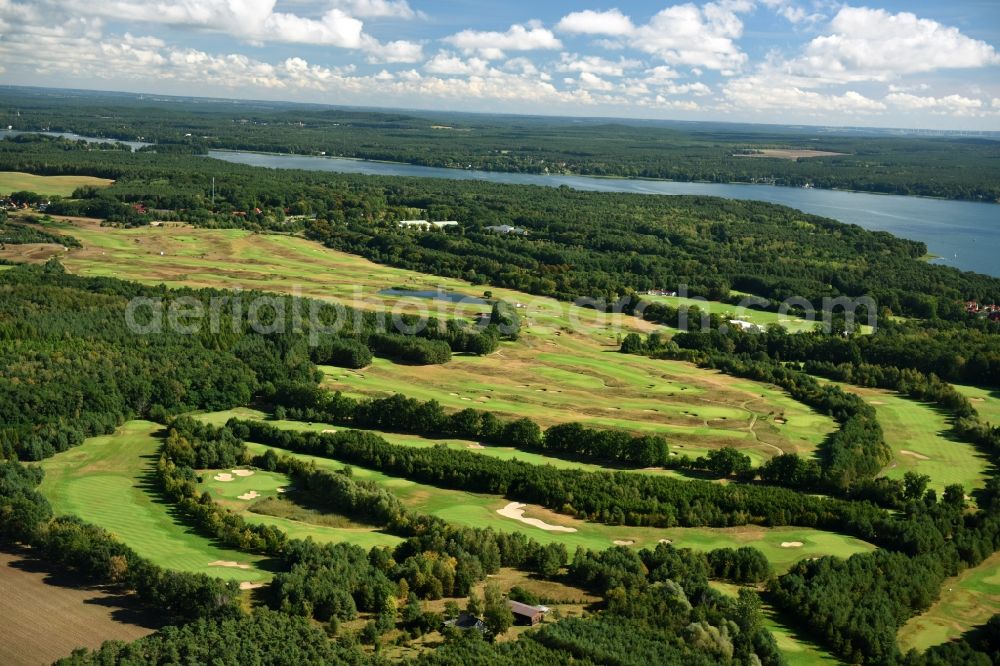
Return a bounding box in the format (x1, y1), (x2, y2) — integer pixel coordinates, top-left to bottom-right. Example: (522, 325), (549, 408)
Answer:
(0, 552), (157, 666)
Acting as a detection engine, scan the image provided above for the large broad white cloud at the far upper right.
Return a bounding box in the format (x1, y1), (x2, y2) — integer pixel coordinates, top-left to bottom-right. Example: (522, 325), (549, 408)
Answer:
(788, 7), (1000, 83)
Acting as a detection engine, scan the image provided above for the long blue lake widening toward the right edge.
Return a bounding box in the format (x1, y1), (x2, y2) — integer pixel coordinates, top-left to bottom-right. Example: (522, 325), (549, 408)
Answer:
(209, 150), (1000, 277)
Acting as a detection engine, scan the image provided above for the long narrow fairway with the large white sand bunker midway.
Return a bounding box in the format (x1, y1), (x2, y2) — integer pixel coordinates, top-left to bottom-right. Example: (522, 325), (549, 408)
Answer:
(234, 442), (874, 572)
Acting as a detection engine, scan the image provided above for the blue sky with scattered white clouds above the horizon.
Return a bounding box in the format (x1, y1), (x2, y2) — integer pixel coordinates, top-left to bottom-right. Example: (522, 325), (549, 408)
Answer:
(0, 0), (1000, 130)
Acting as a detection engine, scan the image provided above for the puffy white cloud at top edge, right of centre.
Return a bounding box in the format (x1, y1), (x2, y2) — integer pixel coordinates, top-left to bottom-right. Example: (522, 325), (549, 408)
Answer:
(630, 0), (753, 75)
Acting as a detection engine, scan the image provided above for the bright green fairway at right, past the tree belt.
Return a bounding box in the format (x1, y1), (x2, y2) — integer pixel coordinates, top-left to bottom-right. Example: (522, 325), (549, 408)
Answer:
(840, 384), (989, 496)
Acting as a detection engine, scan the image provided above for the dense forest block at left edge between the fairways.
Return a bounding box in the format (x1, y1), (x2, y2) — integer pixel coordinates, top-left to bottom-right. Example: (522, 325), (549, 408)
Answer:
(0, 260), (499, 460)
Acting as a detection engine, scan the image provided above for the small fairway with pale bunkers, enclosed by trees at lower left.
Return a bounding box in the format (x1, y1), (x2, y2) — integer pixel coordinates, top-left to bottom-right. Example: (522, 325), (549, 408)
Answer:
(198, 462), (402, 550)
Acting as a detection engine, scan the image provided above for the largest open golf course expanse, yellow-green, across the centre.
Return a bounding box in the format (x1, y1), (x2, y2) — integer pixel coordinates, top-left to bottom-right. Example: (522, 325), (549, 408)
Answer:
(8, 218), (835, 464)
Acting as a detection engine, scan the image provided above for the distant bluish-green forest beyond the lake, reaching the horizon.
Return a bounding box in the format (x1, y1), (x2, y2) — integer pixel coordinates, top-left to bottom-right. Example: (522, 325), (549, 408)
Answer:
(0, 89), (1000, 201)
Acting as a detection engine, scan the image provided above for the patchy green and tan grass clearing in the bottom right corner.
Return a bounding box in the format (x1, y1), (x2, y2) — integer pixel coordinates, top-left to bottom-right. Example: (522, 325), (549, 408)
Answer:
(898, 553), (1000, 651)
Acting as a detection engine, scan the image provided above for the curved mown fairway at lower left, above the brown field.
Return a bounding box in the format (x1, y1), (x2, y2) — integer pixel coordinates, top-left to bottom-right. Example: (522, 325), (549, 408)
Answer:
(41, 421), (270, 582)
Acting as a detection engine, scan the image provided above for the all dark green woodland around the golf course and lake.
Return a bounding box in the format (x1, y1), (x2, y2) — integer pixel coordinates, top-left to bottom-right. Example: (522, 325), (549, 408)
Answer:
(0, 91), (1000, 666)
